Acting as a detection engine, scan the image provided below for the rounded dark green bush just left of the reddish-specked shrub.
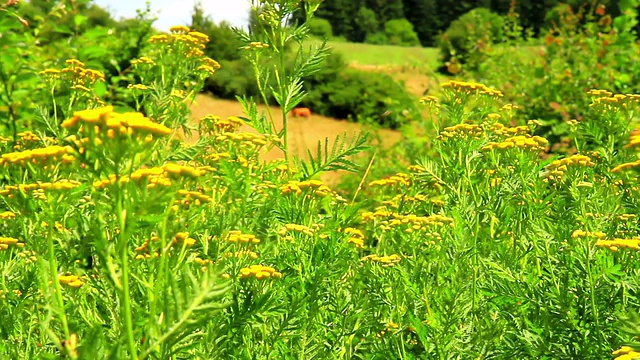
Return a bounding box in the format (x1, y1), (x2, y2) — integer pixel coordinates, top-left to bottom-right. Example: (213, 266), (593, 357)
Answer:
(438, 8), (504, 69)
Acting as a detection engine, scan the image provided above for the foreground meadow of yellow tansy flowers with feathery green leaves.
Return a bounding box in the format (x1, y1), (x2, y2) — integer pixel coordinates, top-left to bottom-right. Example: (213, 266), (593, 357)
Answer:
(0, 0), (640, 360)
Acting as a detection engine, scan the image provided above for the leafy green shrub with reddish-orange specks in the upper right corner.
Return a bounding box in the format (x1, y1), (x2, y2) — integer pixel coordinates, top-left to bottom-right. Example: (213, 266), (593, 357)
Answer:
(474, 0), (640, 150)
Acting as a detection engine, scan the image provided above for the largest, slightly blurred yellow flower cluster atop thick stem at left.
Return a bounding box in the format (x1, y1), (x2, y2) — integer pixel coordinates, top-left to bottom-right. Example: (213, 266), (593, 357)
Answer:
(61, 106), (171, 139)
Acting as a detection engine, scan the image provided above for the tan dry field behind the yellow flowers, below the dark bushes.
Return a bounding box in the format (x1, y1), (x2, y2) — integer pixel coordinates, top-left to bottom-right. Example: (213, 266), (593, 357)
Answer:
(187, 94), (401, 183)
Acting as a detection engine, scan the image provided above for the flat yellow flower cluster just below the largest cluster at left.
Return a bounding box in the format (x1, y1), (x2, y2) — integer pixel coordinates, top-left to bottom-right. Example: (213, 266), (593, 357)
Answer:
(93, 163), (209, 190)
